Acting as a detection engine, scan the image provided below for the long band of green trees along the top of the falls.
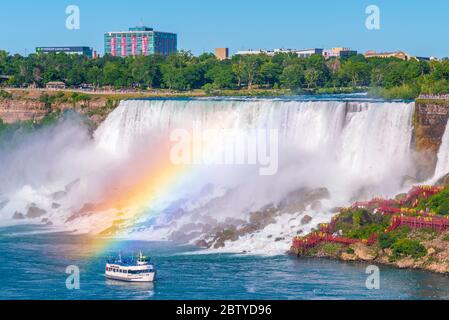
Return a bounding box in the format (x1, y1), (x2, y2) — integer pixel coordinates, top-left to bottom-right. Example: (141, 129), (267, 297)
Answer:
(0, 51), (449, 98)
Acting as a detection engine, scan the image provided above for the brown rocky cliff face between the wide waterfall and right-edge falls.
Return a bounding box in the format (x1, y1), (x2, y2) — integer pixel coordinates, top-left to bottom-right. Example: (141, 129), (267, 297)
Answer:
(414, 99), (449, 179)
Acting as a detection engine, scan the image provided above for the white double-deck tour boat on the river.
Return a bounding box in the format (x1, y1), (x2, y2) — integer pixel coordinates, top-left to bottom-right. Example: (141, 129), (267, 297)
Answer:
(105, 252), (156, 282)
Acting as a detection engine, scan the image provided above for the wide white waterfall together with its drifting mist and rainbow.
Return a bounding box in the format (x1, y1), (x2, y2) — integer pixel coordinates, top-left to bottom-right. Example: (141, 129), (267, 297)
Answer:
(0, 99), (415, 254)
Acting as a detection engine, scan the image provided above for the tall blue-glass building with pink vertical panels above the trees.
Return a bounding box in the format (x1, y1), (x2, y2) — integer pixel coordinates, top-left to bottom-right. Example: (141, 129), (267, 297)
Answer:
(104, 27), (178, 57)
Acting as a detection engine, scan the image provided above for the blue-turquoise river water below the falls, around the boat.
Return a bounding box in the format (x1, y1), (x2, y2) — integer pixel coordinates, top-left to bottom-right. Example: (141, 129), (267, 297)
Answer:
(0, 226), (449, 300)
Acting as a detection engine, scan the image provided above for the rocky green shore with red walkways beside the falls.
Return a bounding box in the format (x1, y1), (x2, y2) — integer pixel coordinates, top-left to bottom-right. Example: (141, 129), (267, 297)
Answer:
(289, 187), (449, 274)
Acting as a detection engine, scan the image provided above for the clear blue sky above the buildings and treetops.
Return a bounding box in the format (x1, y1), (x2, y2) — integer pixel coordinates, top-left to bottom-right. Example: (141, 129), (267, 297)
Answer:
(0, 0), (449, 57)
